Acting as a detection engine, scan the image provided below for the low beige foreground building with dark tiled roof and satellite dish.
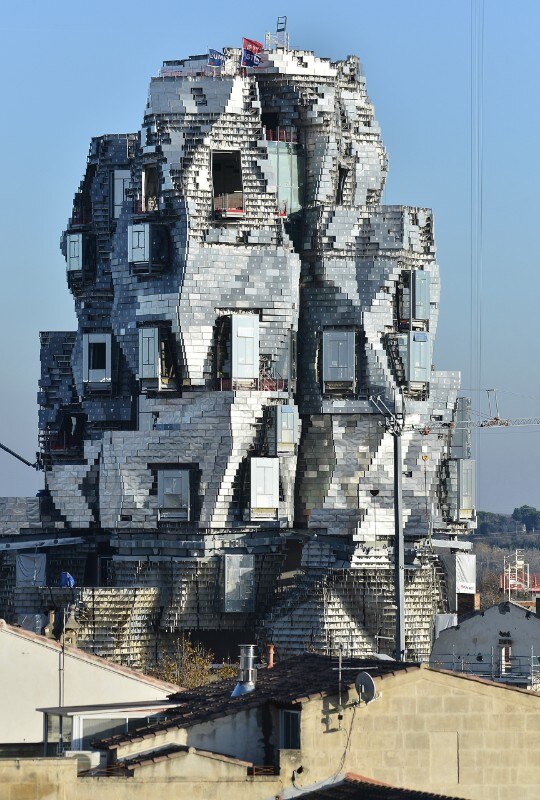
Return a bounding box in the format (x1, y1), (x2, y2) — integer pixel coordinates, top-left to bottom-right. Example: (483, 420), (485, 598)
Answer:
(4, 654), (540, 800)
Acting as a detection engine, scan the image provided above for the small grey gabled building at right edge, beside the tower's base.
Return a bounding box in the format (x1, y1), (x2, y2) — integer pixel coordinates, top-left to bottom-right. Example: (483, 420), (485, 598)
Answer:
(429, 600), (540, 690)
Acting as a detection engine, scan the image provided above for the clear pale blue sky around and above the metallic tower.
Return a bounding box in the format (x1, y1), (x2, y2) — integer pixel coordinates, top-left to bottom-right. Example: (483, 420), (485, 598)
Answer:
(0, 0), (540, 511)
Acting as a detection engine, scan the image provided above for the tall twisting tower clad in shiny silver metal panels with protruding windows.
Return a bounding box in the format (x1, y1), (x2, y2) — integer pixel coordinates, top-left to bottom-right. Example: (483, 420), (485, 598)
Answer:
(0, 40), (475, 666)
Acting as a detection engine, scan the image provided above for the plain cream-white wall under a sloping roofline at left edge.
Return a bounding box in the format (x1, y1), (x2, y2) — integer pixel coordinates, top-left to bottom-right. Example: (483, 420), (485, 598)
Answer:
(0, 623), (171, 744)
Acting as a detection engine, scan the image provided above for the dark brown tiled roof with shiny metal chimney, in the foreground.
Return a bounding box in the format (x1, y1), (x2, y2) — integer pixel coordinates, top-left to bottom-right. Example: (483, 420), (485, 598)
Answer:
(101, 653), (419, 749)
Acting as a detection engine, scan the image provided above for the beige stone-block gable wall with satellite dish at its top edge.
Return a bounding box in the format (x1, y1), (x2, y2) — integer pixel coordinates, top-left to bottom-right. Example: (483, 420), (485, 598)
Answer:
(288, 668), (540, 800)
